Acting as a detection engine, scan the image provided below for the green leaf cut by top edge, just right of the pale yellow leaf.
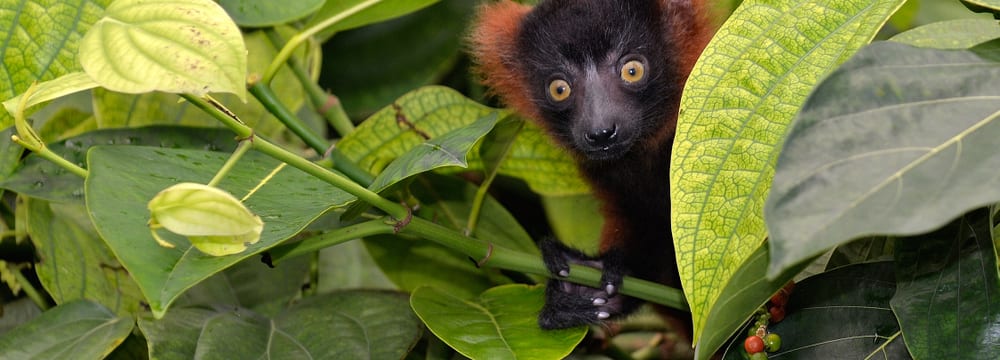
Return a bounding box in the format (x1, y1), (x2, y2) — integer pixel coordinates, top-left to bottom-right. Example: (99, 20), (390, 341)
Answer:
(219, 0), (322, 27)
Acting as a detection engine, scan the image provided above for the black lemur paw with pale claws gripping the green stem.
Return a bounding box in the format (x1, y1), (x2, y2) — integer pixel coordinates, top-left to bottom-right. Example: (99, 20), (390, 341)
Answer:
(538, 240), (631, 329)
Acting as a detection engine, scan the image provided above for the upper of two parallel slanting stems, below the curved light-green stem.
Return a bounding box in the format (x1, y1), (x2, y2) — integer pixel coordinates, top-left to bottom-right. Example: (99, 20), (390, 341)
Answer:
(265, 28), (354, 137)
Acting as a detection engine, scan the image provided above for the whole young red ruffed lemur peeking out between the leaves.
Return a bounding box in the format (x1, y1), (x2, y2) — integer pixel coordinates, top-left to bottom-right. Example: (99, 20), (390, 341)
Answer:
(471, 0), (712, 336)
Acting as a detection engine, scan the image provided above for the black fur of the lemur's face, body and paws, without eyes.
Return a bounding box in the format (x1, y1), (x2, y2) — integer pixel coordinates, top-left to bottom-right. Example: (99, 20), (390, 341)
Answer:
(517, 0), (690, 329)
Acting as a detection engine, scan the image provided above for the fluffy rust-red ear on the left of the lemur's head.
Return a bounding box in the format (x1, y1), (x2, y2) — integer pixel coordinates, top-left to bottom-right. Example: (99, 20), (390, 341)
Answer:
(470, 0), (538, 119)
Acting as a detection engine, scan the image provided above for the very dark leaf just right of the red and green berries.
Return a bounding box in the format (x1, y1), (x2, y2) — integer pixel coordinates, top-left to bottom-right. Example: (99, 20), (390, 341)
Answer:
(726, 262), (910, 360)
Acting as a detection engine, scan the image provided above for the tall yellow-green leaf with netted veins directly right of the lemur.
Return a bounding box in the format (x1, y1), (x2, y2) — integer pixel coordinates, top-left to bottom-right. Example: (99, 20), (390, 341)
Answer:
(670, 0), (903, 341)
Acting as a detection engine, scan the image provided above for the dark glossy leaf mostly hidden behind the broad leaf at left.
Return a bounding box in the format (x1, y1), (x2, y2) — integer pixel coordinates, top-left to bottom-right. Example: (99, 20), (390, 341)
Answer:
(0, 126), (236, 202)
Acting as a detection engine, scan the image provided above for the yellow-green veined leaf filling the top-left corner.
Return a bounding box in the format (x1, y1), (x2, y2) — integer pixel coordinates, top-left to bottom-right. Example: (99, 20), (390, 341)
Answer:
(0, 0), (111, 129)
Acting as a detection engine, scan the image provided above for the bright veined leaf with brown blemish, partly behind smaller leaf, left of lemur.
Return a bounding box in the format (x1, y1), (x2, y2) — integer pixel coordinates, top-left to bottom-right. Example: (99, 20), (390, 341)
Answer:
(337, 86), (589, 195)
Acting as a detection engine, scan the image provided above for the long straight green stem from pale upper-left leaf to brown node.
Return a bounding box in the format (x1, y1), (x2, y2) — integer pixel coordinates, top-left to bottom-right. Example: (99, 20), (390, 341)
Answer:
(181, 94), (409, 219)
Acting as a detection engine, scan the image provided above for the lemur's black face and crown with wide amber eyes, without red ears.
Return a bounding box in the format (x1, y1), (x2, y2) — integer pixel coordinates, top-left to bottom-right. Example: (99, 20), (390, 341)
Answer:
(516, 0), (683, 161)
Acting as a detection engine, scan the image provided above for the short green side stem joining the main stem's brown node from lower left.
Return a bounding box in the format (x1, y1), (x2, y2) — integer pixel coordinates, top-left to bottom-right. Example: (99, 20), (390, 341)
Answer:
(268, 217), (393, 265)
